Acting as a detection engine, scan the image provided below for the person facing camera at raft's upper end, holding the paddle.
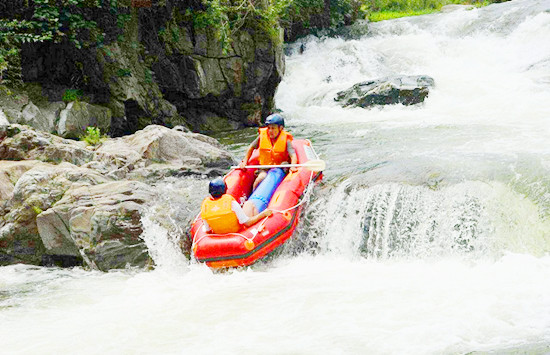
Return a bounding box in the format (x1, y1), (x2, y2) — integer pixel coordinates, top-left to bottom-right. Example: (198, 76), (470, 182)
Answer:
(239, 113), (298, 190)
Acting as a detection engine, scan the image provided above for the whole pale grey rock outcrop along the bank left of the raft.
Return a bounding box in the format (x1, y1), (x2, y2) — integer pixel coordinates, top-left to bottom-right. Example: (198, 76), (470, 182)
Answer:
(0, 125), (235, 270)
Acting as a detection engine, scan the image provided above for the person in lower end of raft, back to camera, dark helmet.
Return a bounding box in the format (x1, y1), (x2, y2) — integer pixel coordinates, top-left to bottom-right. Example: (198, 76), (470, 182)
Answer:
(201, 177), (273, 234)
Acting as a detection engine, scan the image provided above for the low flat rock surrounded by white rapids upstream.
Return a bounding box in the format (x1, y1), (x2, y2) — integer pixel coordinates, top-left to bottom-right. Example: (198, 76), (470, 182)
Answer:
(334, 75), (434, 108)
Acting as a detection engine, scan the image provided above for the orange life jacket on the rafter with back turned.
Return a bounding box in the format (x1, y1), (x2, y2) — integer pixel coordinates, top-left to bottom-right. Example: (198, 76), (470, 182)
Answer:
(201, 194), (241, 234)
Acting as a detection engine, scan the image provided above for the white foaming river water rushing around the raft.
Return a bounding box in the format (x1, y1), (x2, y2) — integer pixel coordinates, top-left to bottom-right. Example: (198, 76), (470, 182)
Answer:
(0, 0), (550, 354)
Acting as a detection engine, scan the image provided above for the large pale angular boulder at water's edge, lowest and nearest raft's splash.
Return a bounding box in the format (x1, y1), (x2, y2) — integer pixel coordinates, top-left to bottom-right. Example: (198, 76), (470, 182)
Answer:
(37, 181), (154, 271)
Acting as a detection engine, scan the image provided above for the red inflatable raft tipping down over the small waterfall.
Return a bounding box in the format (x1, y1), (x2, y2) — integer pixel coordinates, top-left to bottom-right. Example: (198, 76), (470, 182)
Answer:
(190, 139), (322, 268)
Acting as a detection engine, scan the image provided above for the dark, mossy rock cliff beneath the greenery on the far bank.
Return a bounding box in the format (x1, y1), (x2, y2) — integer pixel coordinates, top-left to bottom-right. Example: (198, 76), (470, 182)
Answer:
(11, 0), (284, 137)
